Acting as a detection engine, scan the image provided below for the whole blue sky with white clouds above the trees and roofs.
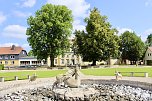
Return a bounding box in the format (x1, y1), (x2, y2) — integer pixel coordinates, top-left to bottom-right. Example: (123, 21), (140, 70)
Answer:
(0, 0), (152, 52)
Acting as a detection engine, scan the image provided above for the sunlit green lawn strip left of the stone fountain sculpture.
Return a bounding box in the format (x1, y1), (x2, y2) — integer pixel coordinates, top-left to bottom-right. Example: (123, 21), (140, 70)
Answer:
(0, 70), (66, 81)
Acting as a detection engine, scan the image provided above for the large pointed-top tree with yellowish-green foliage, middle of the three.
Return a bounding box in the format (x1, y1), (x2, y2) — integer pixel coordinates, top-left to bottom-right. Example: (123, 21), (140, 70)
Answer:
(75, 8), (119, 65)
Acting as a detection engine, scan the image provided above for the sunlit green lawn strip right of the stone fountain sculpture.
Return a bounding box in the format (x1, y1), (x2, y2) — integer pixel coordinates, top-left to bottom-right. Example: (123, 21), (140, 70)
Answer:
(81, 67), (152, 77)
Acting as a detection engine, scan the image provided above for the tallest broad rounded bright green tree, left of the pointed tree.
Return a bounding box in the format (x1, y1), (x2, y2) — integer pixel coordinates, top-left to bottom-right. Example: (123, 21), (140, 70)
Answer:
(26, 4), (73, 67)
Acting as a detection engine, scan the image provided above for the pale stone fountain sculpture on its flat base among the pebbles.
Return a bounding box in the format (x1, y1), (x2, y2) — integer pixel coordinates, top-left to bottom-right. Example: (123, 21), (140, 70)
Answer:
(52, 65), (97, 100)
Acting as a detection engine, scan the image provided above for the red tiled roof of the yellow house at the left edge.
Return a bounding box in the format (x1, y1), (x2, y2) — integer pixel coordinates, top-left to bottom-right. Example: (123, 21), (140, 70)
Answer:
(0, 46), (23, 54)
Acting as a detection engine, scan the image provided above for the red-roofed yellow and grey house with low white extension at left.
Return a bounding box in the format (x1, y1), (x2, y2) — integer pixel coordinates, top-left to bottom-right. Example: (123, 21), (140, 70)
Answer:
(0, 45), (44, 67)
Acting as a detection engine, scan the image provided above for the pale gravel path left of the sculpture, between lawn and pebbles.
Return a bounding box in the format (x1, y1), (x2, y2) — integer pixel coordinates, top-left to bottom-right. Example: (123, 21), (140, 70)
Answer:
(0, 78), (55, 96)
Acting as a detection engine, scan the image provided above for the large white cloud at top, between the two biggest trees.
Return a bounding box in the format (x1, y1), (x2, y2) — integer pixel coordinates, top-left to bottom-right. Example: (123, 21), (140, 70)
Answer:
(47, 0), (90, 18)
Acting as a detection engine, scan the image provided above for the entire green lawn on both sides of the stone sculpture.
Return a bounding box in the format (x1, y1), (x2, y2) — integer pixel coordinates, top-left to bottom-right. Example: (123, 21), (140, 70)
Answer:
(0, 67), (152, 81)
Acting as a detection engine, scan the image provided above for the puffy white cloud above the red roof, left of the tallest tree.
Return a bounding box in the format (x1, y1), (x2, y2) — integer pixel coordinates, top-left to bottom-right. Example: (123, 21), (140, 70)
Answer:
(2, 25), (27, 39)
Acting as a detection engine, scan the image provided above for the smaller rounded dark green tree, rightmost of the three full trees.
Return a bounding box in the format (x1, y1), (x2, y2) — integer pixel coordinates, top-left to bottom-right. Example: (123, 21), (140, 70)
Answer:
(120, 31), (145, 64)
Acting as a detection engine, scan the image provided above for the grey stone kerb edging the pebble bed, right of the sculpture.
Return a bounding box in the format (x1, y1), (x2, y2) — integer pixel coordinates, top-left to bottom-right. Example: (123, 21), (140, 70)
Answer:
(81, 79), (152, 91)
